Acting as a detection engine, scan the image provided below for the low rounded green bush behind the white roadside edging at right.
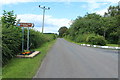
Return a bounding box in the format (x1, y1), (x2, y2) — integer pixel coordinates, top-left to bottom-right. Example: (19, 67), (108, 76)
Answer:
(86, 35), (106, 46)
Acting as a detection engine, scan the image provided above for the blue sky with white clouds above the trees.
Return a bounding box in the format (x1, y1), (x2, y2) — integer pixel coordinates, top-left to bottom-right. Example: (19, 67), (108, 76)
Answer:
(0, 0), (119, 33)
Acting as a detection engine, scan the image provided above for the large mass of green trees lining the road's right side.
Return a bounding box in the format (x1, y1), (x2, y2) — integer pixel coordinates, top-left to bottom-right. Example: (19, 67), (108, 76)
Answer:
(63, 6), (120, 45)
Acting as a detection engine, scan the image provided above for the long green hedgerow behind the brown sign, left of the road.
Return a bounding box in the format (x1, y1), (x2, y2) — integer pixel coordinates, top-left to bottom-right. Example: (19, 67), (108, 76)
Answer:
(0, 11), (55, 66)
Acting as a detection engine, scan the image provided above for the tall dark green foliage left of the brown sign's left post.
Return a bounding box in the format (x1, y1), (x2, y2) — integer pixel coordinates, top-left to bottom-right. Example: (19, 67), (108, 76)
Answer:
(1, 11), (21, 65)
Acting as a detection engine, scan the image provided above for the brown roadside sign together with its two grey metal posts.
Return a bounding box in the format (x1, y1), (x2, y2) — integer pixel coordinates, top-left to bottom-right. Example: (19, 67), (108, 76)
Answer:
(17, 23), (34, 52)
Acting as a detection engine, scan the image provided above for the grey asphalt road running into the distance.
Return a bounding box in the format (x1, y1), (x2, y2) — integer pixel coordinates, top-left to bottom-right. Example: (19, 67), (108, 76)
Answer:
(34, 38), (118, 78)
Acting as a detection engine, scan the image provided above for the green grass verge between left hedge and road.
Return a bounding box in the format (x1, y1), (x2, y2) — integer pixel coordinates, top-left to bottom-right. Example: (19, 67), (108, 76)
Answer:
(2, 40), (55, 78)
